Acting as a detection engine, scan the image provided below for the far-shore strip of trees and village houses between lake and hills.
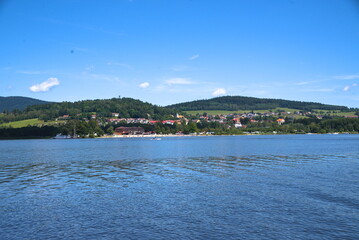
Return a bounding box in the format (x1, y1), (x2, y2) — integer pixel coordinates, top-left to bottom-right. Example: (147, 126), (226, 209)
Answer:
(0, 113), (359, 139)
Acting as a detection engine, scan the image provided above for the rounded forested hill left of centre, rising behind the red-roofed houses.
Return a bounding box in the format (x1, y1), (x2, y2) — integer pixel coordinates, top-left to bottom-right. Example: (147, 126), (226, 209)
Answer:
(19, 98), (176, 120)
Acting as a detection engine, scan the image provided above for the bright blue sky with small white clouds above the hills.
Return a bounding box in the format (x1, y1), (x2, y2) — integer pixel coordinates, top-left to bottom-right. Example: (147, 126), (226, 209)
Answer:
(0, 0), (359, 107)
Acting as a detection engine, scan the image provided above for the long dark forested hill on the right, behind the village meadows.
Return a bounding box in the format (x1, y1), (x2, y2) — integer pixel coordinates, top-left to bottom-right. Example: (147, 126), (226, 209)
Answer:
(168, 96), (349, 111)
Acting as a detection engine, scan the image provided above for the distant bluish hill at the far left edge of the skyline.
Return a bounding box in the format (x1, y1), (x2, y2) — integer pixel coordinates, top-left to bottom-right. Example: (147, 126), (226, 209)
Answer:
(0, 97), (50, 112)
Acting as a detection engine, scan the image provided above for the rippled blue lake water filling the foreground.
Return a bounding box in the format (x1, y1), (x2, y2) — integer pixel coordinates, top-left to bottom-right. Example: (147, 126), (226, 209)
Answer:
(0, 135), (359, 239)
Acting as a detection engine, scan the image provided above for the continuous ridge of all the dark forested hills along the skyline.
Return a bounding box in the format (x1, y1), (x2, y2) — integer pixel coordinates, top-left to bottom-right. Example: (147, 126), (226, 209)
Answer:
(0, 96), (350, 117)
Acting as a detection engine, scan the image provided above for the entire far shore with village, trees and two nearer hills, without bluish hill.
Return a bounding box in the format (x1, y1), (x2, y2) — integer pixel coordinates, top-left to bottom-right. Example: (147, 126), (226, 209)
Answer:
(0, 96), (359, 139)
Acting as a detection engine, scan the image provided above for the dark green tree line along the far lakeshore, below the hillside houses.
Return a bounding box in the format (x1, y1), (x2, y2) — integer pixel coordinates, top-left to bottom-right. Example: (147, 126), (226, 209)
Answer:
(0, 118), (359, 139)
